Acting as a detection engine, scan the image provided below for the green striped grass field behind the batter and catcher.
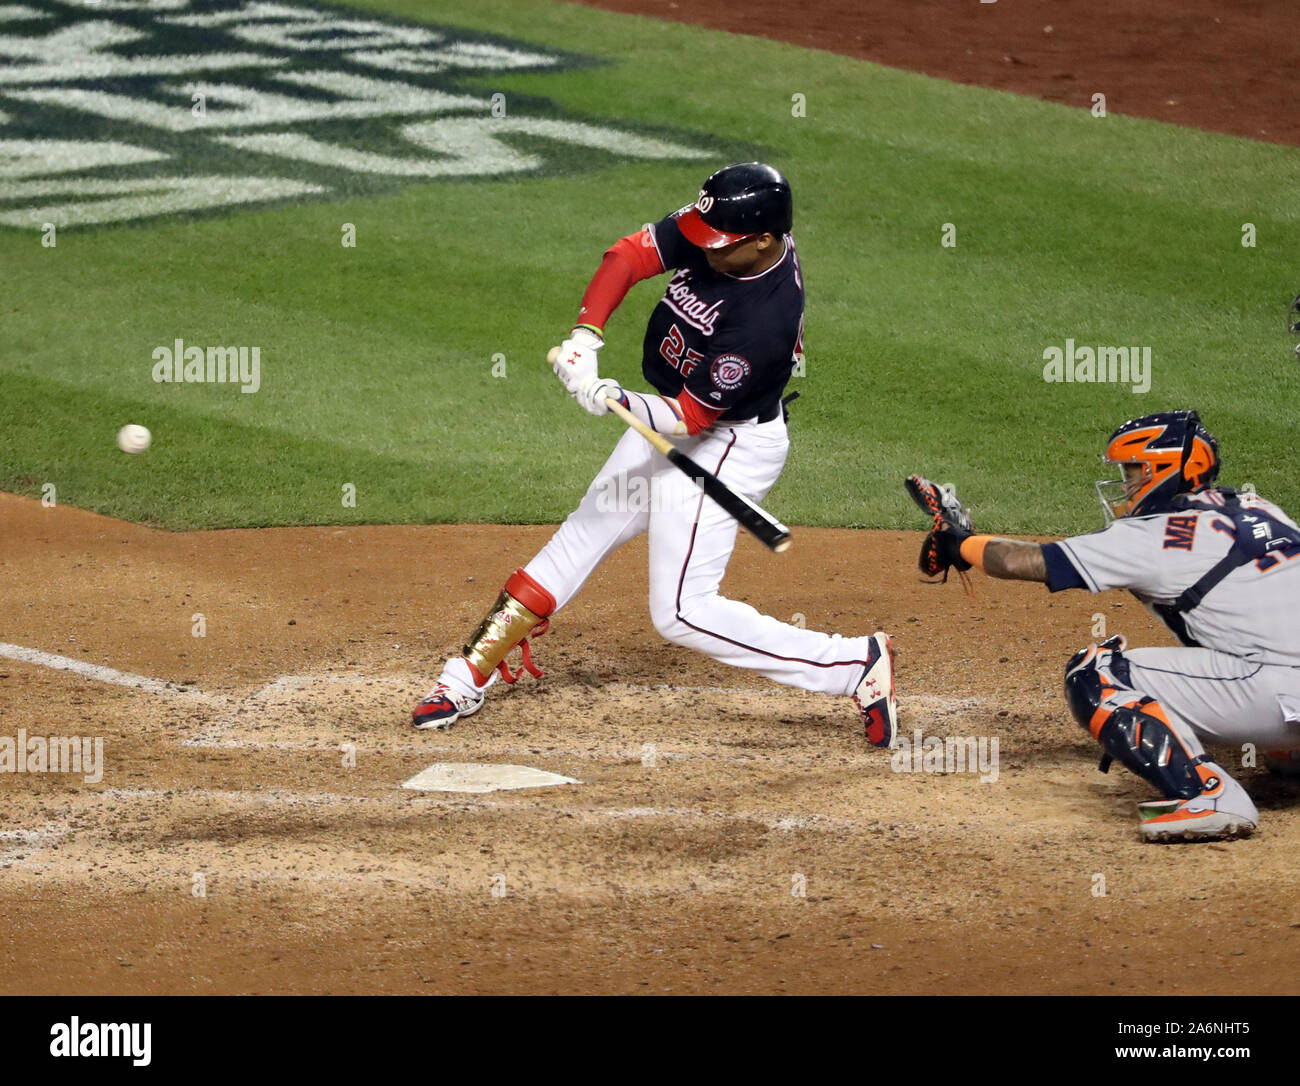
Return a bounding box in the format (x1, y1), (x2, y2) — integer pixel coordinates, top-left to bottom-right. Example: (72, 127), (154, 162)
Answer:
(0, 0), (1300, 533)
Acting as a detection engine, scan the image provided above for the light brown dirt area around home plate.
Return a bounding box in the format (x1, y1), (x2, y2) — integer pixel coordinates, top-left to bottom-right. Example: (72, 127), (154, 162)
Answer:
(0, 496), (1300, 994)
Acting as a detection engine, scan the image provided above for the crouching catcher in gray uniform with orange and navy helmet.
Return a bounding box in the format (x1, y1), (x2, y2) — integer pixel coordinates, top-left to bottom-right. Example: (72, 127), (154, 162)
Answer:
(909, 411), (1300, 841)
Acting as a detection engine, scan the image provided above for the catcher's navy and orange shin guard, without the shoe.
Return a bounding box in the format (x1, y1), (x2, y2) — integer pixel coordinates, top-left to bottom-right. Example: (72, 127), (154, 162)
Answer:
(1065, 637), (1219, 800)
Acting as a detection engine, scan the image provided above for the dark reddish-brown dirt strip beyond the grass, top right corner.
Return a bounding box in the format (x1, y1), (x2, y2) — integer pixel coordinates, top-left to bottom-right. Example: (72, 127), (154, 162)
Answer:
(577, 0), (1300, 144)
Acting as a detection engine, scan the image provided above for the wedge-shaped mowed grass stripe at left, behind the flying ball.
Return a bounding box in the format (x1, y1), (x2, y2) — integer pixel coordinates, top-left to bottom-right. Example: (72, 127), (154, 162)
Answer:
(0, 373), (590, 528)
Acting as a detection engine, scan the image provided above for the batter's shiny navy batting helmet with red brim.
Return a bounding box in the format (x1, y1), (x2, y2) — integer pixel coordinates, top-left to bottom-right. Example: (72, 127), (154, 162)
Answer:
(677, 163), (794, 248)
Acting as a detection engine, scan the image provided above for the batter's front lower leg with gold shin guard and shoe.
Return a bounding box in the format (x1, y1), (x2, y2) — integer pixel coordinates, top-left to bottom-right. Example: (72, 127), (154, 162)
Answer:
(411, 570), (555, 728)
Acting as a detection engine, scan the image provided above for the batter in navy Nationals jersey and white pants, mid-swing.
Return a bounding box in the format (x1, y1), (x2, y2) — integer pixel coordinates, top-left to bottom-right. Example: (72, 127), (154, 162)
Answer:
(413, 163), (897, 747)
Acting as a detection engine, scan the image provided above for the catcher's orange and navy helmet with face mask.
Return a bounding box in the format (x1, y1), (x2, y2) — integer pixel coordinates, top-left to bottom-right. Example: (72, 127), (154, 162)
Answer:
(1097, 411), (1219, 524)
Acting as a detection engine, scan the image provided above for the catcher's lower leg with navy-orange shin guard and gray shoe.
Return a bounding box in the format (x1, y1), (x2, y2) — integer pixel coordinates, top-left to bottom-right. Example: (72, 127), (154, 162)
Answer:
(1065, 637), (1258, 840)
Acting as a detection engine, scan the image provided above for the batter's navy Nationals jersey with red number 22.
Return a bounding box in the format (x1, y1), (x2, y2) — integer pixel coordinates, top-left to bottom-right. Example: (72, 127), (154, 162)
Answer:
(641, 208), (803, 421)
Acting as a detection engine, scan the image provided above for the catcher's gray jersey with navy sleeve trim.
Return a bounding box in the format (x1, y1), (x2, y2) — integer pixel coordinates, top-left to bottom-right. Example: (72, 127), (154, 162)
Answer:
(1045, 492), (1300, 667)
